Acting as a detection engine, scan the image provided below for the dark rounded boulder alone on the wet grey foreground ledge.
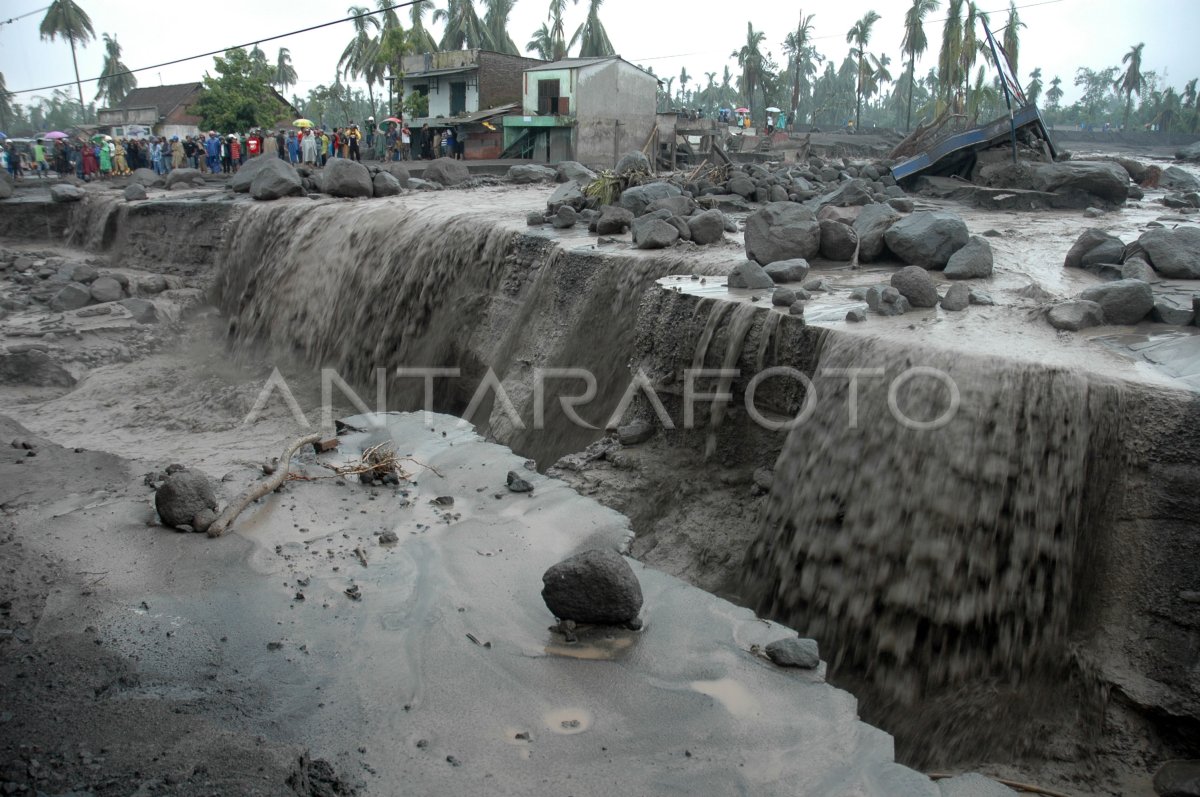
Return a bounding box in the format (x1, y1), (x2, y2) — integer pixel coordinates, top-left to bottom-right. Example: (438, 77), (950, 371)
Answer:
(541, 550), (642, 625)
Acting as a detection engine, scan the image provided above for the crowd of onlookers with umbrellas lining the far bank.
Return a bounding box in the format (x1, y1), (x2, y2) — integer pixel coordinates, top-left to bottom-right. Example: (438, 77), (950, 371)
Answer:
(0, 118), (467, 181)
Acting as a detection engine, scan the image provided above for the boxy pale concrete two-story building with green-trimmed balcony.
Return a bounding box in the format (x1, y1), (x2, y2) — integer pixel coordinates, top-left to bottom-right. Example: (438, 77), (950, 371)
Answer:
(504, 55), (659, 167)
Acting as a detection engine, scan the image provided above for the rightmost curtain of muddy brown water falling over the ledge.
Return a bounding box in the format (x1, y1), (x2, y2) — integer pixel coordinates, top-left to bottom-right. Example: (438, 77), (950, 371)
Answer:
(745, 334), (1122, 759)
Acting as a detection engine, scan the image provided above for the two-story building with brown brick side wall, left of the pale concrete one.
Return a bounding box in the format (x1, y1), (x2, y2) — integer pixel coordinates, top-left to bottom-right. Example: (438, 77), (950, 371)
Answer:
(400, 49), (545, 158)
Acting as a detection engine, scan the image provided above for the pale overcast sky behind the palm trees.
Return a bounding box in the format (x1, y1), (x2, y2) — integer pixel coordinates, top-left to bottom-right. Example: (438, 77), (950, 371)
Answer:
(0, 0), (1200, 110)
